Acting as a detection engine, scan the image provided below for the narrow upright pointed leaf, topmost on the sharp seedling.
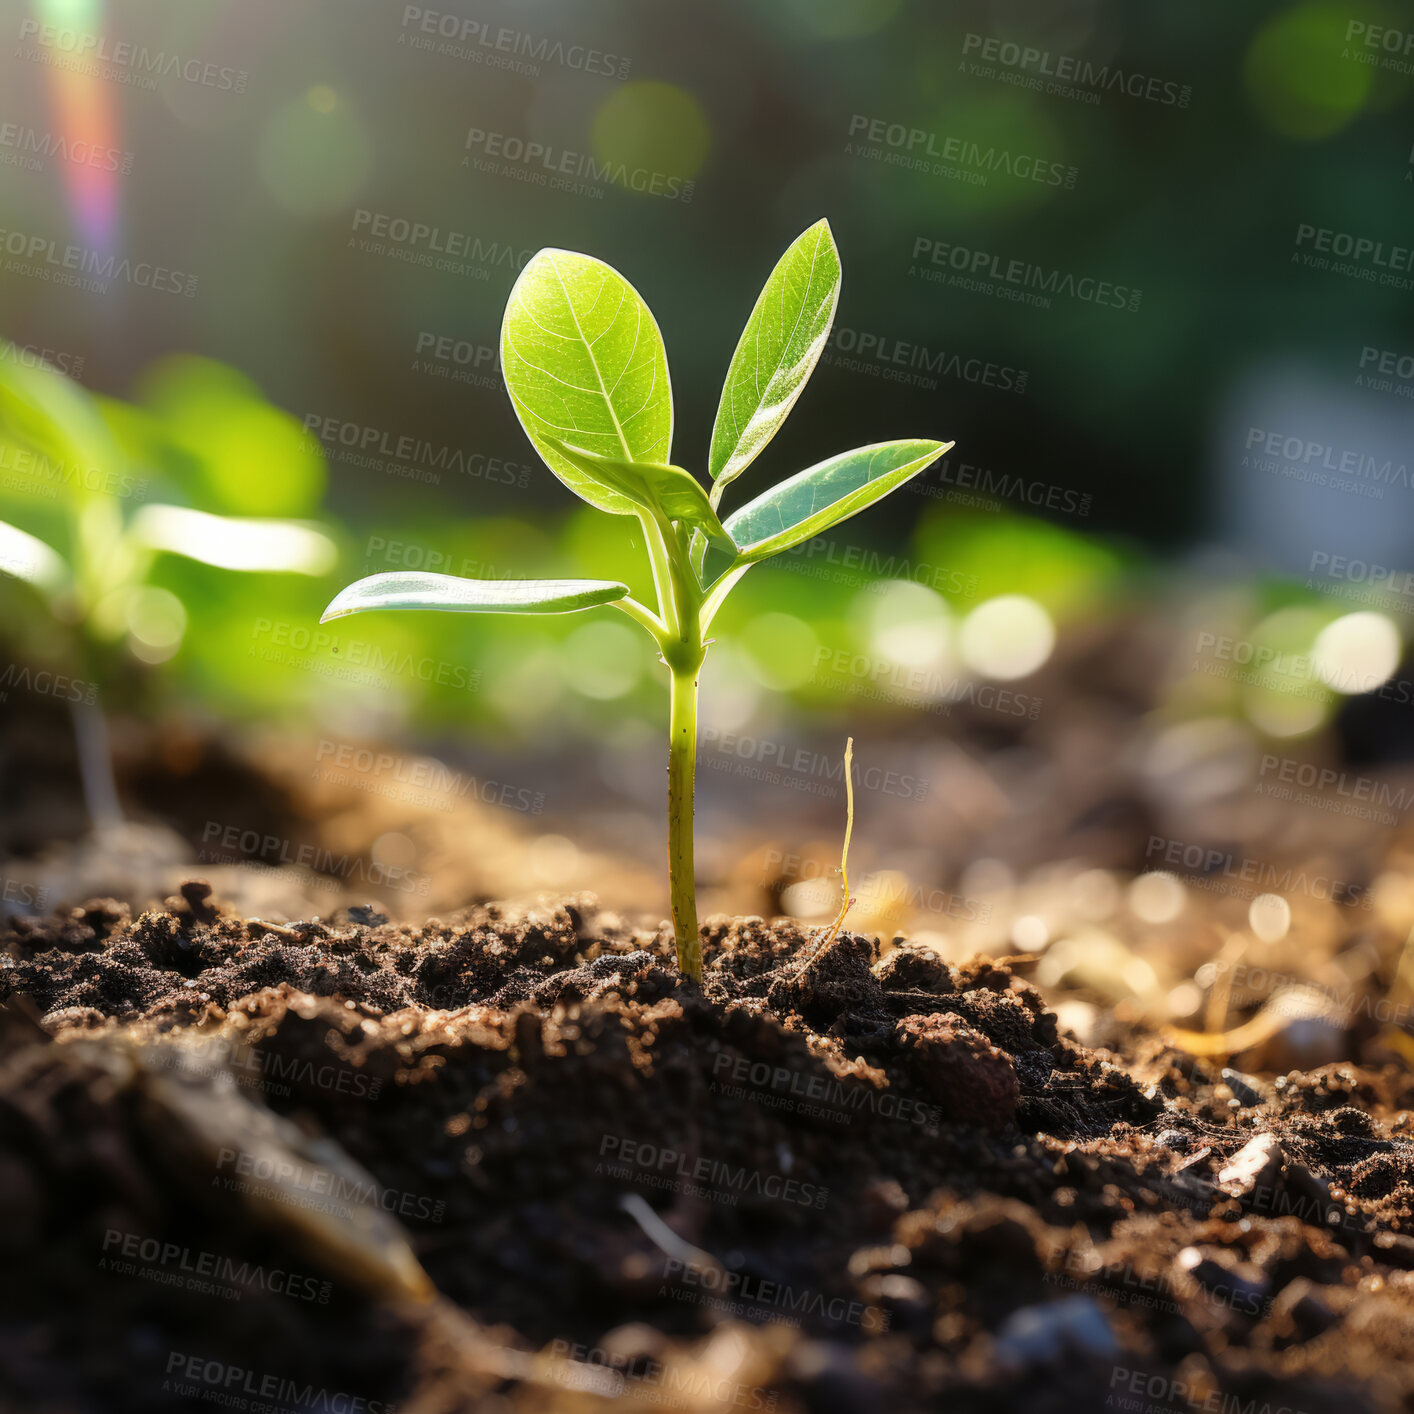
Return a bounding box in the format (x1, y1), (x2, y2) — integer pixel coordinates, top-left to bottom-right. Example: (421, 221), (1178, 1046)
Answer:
(707, 221), (840, 486)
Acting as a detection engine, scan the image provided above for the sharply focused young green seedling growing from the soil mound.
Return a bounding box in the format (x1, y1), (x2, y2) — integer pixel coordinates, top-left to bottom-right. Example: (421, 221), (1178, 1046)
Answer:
(324, 221), (952, 980)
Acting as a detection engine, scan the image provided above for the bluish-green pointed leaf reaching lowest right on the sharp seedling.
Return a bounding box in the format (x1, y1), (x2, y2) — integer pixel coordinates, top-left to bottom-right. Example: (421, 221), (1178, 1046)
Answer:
(727, 438), (953, 564)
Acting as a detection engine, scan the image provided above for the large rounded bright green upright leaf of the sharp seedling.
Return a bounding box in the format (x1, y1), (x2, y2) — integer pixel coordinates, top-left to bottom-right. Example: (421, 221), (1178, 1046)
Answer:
(501, 249), (673, 515)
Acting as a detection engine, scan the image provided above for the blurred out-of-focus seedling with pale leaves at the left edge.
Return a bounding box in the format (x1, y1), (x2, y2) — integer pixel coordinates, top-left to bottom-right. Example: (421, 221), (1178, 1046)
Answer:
(0, 353), (337, 829)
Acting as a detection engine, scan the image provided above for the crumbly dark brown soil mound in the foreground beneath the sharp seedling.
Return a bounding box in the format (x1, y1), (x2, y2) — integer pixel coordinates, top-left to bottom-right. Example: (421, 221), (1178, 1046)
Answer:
(0, 884), (1414, 1414)
